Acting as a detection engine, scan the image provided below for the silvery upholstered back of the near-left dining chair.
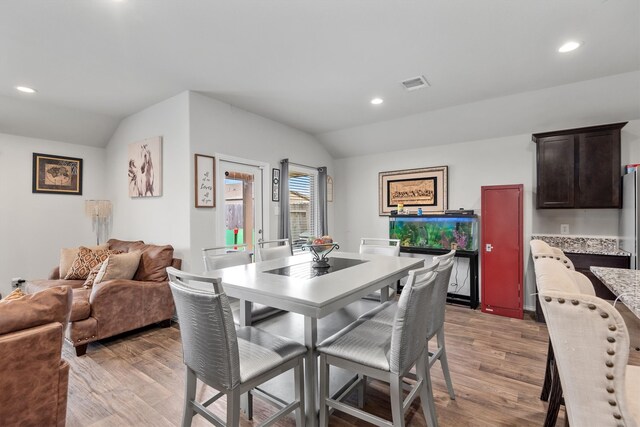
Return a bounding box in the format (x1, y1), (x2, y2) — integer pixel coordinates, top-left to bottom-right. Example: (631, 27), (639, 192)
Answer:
(167, 268), (240, 390)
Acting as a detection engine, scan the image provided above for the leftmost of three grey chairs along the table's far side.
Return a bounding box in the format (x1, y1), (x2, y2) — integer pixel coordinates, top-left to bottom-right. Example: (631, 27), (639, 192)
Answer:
(202, 244), (282, 324)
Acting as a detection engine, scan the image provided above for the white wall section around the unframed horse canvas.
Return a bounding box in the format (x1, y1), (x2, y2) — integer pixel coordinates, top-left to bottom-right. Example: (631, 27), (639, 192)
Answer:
(105, 92), (191, 269)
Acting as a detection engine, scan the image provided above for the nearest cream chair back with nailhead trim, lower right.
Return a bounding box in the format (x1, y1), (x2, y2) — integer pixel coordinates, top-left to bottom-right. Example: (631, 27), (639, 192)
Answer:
(540, 291), (640, 427)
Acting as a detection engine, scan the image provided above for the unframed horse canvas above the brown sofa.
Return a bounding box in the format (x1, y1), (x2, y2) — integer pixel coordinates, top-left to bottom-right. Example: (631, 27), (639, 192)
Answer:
(129, 136), (162, 197)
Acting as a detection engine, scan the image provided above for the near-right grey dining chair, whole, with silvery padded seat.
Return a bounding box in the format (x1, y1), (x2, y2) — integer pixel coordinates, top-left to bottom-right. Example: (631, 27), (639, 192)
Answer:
(318, 262), (438, 427)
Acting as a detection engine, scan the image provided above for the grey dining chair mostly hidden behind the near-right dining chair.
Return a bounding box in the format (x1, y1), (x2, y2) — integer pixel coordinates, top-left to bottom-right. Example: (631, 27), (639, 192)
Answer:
(360, 250), (456, 408)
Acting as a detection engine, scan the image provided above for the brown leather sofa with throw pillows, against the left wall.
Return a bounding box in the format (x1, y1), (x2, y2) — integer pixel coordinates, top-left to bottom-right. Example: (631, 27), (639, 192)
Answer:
(24, 239), (182, 356)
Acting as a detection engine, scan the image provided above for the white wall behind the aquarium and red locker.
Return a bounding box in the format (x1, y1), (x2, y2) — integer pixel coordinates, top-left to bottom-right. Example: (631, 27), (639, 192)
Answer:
(334, 120), (640, 309)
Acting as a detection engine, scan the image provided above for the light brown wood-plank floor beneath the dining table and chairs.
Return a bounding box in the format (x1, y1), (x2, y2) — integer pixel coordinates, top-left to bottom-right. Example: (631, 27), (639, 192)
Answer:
(63, 305), (640, 427)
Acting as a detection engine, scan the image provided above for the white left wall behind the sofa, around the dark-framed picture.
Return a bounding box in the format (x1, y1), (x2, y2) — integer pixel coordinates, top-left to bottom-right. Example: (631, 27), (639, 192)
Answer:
(0, 134), (106, 295)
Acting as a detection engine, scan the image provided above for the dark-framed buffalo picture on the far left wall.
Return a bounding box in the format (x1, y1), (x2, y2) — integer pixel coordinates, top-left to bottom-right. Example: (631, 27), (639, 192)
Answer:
(32, 153), (82, 195)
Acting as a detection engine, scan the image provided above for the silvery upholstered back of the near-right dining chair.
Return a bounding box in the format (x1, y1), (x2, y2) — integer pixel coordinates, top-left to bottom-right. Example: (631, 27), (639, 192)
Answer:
(389, 261), (438, 375)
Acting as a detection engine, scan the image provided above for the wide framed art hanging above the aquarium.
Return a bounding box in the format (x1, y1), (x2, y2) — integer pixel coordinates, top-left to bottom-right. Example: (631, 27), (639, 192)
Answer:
(378, 166), (449, 215)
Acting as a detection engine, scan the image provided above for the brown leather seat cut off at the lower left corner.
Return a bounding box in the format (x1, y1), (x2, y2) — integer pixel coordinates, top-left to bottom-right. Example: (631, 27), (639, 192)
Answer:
(0, 288), (71, 427)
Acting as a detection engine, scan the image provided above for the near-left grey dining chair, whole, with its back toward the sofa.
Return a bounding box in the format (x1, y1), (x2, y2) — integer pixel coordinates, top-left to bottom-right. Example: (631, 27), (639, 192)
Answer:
(167, 267), (307, 427)
